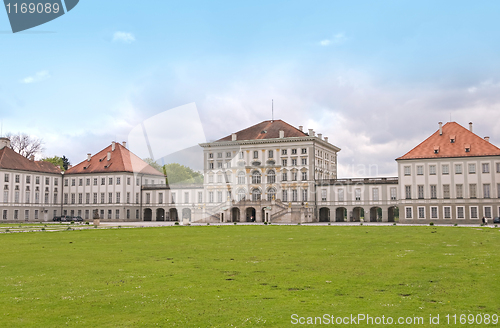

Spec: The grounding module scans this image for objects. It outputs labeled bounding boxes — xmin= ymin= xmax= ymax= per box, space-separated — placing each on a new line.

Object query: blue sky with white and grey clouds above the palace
xmin=0 ymin=0 xmax=500 ymax=178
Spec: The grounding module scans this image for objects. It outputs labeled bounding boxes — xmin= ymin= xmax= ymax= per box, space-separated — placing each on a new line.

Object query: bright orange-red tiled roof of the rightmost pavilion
xmin=397 ymin=122 xmax=500 ymax=159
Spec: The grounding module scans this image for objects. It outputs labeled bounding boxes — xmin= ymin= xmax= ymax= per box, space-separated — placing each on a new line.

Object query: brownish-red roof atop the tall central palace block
xmin=216 ymin=120 xmax=307 ymax=142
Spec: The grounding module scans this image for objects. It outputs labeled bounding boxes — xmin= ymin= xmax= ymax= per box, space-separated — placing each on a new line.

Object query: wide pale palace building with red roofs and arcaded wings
xmin=0 ymin=120 xmax=500 ymax=223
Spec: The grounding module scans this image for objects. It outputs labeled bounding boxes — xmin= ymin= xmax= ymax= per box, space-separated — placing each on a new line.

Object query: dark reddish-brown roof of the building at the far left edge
xmin=0 ymin=147 xmax=61 ymax=174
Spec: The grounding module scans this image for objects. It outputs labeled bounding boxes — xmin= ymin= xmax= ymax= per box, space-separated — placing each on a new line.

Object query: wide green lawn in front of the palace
xmin=0 ymin=225 xmax=500 ymax=327
